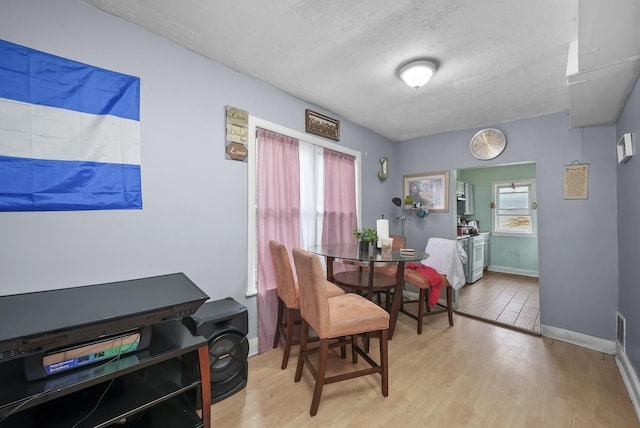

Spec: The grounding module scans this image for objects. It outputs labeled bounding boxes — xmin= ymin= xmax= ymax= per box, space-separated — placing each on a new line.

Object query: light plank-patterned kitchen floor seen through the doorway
xmin=458 ymin=271 xmax=540 ymax=335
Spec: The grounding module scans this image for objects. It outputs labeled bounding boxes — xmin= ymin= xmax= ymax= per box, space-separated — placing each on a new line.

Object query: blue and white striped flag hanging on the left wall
xmin=0 ymin=40 xmax=142 ymax=211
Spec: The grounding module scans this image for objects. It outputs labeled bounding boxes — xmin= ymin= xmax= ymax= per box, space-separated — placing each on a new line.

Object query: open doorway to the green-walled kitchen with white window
xmin=455 ymin=163 xmax=540 ymax=335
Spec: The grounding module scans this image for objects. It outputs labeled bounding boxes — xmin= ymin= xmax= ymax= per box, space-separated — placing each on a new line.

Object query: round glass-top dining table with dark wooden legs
xmin=307 ymin=242 xmax=429 ymax=339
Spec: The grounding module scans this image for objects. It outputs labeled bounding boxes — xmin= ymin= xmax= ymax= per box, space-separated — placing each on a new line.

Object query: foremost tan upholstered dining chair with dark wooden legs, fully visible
xmin=293 ymin=248 xmax=389 ymax=416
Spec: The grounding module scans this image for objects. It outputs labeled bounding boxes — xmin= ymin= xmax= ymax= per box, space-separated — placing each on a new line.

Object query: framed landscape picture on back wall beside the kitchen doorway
xmin=402 ymin=171 xmax=449 ymax=213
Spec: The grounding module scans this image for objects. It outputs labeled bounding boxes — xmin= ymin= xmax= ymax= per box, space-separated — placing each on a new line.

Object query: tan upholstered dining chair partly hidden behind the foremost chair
xmin=269 ymin=240 xmax=344 ymax=370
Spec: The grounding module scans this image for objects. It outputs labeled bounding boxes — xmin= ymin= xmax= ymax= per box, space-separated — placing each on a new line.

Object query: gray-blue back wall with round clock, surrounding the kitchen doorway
xmin=390 ymin=113 xmax=618 ymax=340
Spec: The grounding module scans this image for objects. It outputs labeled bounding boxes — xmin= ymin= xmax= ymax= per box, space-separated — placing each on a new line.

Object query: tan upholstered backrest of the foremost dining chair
xmin=293 ymin=248 xmax=330 ymax=337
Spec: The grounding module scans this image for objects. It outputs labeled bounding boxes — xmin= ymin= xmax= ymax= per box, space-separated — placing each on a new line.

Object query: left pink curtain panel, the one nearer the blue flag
xmin=257 ymin=128 xmax=300 ymax=352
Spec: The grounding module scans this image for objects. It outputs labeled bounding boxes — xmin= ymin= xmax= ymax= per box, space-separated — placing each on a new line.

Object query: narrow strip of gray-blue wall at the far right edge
xmin=616 ymin=75 xmax=640 ymax=373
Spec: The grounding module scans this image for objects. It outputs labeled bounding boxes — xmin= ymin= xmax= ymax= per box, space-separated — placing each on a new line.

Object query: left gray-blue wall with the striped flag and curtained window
xmin=0 ymin=0 xmax=393 ymax=338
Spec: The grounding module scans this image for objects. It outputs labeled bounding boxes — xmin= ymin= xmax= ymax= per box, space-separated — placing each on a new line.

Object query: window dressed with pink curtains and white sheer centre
xmin=248 ymin=121 xmax=359 ymax=352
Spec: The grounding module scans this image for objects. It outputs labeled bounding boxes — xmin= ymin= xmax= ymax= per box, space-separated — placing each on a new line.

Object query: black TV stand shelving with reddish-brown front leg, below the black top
xmin=0 ymin=276 xmax=211 ymax=428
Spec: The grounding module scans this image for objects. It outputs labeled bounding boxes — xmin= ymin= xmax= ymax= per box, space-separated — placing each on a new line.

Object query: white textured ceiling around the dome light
xmin=85 ymin=0 xmax=640 ymax=141
